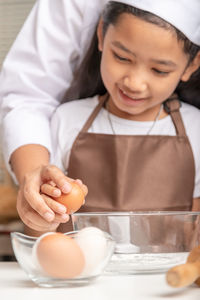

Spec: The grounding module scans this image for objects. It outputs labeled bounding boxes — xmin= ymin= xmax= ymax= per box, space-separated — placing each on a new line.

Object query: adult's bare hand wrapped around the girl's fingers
xmin=17 ymin=165 xmax=86 ymax=234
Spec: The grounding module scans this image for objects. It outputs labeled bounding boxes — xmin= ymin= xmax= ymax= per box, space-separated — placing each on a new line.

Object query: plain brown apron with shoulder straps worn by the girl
xmin=57 ymin=97 xmax=195 ymax=232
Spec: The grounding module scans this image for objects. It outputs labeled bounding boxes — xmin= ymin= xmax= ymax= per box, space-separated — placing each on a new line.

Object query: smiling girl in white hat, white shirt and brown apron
xmin=18 ymin=0 xmax=200 ymax=234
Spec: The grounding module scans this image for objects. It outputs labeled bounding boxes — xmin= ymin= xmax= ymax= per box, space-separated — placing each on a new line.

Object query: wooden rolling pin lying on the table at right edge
xmin=166 ymin=246 xmax=200 ymax=287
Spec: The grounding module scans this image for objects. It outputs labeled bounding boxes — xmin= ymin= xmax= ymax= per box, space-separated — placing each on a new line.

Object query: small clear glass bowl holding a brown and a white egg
xmin=11 ymin=231 xmax=115 ymax=287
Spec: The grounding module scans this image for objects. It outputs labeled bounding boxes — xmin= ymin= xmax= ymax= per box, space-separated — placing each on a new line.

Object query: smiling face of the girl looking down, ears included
xmin=98 ymin=13 xmax=198 ymax=121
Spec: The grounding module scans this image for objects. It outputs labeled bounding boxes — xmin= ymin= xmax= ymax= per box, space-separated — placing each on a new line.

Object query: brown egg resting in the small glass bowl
xmin=36 ymin=233 xmax=85 ymax=279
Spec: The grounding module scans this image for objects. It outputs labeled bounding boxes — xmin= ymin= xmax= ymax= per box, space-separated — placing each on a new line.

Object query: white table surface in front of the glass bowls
xmin=0 ymin=262 xmax=200 ymax=300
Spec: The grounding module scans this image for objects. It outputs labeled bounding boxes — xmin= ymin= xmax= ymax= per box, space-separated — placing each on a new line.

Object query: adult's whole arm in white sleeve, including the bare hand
xmin=0 ymin=0 xmax=108 ymax=234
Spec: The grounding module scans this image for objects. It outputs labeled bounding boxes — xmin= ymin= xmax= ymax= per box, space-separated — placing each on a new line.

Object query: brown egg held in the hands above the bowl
xmin=54 ymin=182 xmax=85 ymax=214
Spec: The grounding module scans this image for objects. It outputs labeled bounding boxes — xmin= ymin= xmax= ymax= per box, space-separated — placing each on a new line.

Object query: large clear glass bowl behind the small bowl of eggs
xmin=72 ymin=211 xmax=200 ymax=275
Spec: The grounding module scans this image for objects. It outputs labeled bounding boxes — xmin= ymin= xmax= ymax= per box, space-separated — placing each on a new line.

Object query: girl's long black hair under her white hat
xmin=64 ymin=1 xmax=200 ymax=108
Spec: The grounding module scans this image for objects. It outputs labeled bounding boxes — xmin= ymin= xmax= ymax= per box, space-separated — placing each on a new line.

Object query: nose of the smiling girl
xmin=124 ymin=74 xmax=147 ymax=93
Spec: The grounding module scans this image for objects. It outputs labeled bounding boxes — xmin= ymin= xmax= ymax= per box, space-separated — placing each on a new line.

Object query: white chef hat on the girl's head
xmin=111 ymin=0 xmax=200 ymax=46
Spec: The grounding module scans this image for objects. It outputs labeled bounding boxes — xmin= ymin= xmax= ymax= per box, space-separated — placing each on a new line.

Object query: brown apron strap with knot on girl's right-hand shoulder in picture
xmin=164 ymin=94 xmax=187 ymax=136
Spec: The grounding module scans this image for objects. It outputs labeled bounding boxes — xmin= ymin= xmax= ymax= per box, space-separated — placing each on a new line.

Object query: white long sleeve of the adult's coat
xmin=0 ymin=0 xmax=108 ymax=176
